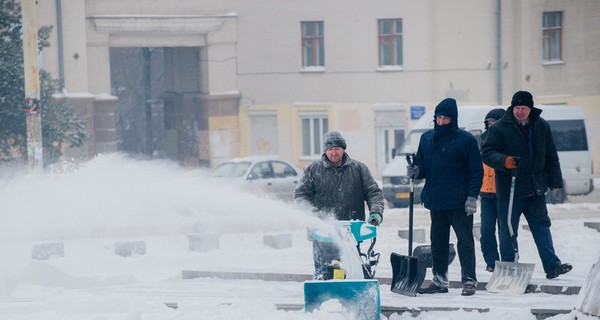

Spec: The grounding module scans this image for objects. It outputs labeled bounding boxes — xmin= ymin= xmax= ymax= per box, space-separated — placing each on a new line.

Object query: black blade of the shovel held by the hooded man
xmin=390 ymin=252 xmax=427 ymax=297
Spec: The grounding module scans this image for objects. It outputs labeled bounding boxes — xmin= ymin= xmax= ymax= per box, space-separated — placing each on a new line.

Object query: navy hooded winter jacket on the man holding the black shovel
xmin=415 ymin=99 xmax=483 ymax=211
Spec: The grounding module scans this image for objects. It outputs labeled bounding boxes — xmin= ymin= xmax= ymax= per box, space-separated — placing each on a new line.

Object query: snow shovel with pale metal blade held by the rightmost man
xmin=485 ymin=157 xmax=535 ymax=294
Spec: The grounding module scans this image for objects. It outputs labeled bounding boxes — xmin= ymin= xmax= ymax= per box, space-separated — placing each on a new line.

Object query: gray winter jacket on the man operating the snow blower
xmin=294 ymin=153 xmax=384 ymax=221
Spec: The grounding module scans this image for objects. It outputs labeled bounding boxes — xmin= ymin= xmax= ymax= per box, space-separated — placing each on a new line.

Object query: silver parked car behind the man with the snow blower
xmin=210 ymin=156 xmax=302 ymax=201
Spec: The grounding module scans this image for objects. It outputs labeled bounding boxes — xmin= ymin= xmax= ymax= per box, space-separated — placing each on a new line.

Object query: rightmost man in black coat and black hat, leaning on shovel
xmin=482 ymin=91 xmax=573 ymax=279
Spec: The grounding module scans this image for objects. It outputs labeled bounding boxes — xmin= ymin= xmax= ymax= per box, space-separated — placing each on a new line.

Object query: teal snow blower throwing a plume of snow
xmin=304 ymin=220 xmax=381 ymax=320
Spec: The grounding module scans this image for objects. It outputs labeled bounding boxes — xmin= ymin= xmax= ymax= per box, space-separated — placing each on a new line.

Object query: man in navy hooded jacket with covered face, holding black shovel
xmin=407 ymin=98 xmax=483 ymax=296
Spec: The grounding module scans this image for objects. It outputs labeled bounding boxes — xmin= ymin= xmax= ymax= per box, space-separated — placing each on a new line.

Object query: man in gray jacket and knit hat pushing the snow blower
xmin=294 ymin=131 xmax=384 ymax=280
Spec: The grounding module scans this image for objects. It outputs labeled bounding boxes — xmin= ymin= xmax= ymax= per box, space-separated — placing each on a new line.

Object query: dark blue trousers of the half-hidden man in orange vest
xmin=479 ymin=197 xmax=500 ymax=268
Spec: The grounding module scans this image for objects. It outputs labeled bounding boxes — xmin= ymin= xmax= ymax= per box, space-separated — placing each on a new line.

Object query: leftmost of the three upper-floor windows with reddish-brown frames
xmin=302 ymin=21 xmax=325 ymax=67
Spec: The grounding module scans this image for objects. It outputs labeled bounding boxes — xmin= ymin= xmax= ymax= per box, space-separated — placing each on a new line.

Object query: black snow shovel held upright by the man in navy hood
xmin=390 ymin=154 xmax=427 ymax=297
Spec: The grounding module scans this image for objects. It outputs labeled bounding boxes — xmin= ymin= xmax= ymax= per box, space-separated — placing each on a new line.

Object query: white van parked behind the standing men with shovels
xmin=382 ymin=105 xmax=593 ymax=208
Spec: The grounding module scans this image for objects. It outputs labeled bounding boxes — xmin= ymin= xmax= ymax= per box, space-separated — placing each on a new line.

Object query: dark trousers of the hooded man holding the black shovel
xmin=430 ymin=208 xmax=477 ymax=287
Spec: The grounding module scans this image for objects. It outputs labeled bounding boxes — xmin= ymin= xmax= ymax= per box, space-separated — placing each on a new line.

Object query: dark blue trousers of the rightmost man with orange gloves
xmin=498 ymin=196 xmax=561 ymax=273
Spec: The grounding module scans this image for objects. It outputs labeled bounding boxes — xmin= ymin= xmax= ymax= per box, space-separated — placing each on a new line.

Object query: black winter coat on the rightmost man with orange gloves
xmin=482 ymin=107 xmax=563 ymax=198
